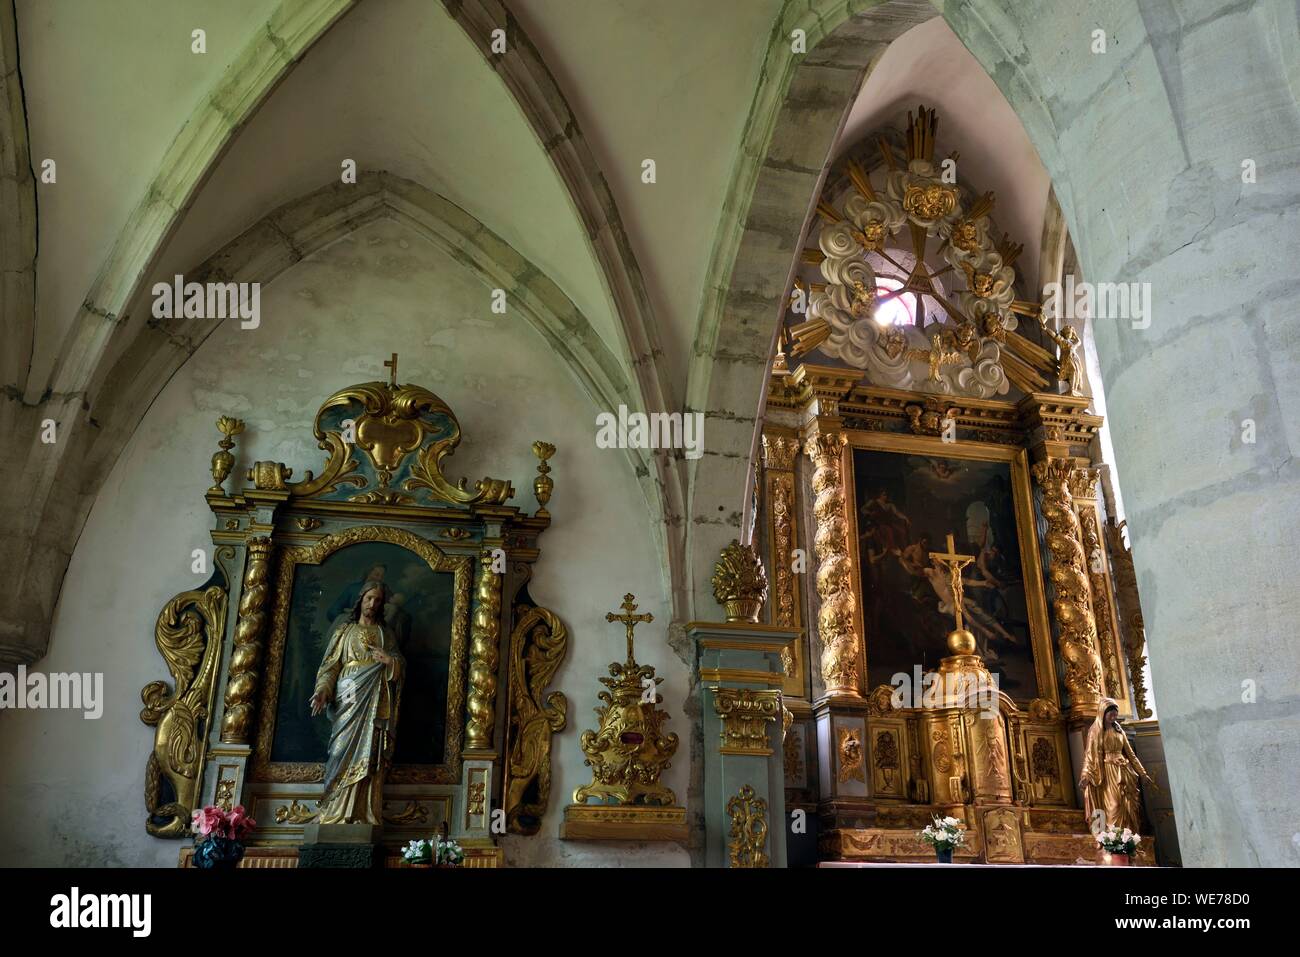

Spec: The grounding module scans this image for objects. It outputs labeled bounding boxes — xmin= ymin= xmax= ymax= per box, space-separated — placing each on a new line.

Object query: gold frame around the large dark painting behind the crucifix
xmin=841 ymin=429 xmax=1061 ymax=710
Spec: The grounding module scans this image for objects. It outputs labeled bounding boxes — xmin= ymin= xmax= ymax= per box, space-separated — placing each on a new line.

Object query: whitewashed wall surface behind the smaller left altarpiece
xmin=0 ymin=221 xmax=689 ymax=866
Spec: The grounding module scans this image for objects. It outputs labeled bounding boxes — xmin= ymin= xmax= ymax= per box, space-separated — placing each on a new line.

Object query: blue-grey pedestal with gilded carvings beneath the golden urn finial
xmin=686 ymin=622 xmax=798 ymax=867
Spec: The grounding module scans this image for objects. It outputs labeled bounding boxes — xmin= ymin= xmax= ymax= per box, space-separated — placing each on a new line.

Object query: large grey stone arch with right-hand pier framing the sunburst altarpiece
xmin=689 ymin=0 xmax=1300 ymax=866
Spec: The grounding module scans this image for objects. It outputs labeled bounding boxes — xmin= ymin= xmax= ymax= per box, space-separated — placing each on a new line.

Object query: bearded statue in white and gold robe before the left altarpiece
xmin=311 ymin=581 xmax=406 ymax=824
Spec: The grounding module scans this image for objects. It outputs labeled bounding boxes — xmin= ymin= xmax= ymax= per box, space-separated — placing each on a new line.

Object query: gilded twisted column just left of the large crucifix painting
xmin=805 ymin=432 xmax=861 ymax=697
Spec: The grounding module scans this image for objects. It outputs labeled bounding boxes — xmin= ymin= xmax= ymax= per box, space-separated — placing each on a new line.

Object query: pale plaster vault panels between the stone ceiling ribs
xmin=17 ymin=0 xmax=780 ymax=402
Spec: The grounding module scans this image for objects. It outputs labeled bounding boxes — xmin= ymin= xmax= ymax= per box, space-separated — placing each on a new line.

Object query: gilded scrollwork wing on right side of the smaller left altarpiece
xmin=506 ymin=607 xmax=568 ymax=833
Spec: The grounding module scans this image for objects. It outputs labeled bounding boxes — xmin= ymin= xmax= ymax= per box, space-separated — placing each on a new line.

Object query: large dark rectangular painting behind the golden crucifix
xmin=853 ymin=449 xmax=1037 ymax=701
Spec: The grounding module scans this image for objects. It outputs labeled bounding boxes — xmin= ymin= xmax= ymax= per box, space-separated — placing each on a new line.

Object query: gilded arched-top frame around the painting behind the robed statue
xmin=251 ymin=525 xmax=473 ymax=784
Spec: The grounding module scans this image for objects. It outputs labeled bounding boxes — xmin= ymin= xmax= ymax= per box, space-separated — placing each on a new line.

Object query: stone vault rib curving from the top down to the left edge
xmin=0 ymin=0 xmax=355 ymax=663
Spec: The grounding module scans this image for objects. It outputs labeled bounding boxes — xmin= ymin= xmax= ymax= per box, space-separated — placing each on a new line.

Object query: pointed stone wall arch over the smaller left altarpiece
xmin=7 ymin=172 xmax=680 ymax=662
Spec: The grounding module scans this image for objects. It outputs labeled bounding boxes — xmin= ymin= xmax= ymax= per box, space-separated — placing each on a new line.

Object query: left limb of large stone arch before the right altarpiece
xmin=686 ymin=0 xmax=939 ymax=616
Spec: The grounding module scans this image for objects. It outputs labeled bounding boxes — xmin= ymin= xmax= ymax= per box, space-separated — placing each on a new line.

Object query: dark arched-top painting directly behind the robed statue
xmin=270 ymin=541 xmax=455 ymax=765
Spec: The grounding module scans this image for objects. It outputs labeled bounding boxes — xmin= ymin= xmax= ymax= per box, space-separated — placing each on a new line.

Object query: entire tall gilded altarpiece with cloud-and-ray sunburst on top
xmin=757 ymin=107 xmax=1149 ymax=863
